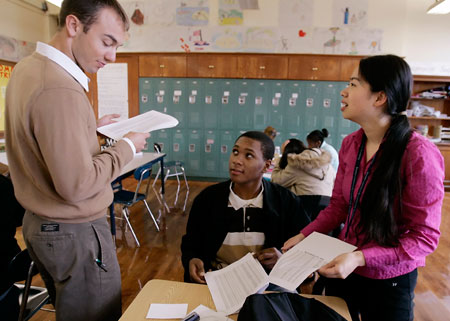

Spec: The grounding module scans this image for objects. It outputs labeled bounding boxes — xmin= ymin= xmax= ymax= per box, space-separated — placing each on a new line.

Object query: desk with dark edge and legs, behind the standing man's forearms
xmin=109 ymin=152 xmax=166 ymax=239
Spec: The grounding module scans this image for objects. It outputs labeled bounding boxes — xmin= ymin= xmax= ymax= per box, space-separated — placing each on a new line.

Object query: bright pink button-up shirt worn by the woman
xmin=302 ymin=129 xmax=444 ymax=279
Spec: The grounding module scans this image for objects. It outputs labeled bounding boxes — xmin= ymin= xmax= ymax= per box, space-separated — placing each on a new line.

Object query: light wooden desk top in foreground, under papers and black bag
xmin=120 ymin=280 xmax=351 ymax=321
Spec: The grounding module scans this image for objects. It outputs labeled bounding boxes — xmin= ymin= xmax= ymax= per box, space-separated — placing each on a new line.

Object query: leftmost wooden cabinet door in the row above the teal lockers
xmin=139 ymin=53 xmax=187 ymax=78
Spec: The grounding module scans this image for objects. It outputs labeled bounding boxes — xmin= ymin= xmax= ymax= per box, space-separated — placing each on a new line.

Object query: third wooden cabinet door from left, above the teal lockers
xmin=237 ymin=55 xmax=289 ymax=79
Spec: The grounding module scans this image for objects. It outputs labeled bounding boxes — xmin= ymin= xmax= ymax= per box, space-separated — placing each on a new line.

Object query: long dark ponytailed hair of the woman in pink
xmin=358 ymin=55 xmax=412 ymax=246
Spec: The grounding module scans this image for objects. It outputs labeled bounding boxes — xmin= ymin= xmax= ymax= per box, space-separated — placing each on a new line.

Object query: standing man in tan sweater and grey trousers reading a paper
xmin=6 ymin=0 xmax=149 ymax=321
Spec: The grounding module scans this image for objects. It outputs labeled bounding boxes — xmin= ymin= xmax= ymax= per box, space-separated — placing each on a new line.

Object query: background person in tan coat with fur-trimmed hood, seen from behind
xmin=272 ymin=138 xmax=336 ymax=220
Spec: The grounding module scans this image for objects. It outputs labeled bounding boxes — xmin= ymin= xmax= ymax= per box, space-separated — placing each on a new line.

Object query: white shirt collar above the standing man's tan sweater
xmin=36 ymin=42 xmax=89 ymax=91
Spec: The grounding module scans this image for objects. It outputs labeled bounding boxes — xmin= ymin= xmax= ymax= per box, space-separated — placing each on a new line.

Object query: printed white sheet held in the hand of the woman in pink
xmin=269 ymin=232 xmax=356 ymax=291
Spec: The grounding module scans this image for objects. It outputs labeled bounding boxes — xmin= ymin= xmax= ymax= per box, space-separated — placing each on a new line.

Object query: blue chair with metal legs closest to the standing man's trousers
xmin=112 ymin=164 xmax=159 ymax=247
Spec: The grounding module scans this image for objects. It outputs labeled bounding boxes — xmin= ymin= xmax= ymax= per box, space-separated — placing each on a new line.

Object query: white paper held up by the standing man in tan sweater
xmin=97 ymin=110 xmax=178 ymax=140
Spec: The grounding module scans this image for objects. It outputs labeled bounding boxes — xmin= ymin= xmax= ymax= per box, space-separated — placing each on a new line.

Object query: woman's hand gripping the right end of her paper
xmin=319 ymin=251 xmax=366 ymax=279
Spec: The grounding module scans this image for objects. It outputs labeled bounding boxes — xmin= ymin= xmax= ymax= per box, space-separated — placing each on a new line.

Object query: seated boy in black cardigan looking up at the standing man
xmin=181 ymin=131 xmax=310 ymax=283
